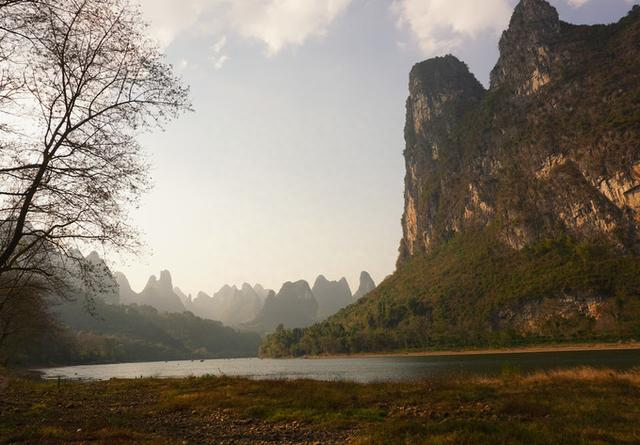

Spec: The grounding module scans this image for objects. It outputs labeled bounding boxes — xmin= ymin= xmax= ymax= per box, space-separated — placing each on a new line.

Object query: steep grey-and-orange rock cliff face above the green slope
xmin=398 ymin=0 xmax=640 ymax=265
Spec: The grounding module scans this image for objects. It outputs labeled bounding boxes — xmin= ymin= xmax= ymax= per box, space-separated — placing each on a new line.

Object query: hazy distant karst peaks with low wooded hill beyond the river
xmin=43 ymin=252 xmax=375 ymax=364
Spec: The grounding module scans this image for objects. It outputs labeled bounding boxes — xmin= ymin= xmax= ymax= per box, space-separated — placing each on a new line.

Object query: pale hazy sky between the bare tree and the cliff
xmin=117 ymin=0 xmax=637 ymax=294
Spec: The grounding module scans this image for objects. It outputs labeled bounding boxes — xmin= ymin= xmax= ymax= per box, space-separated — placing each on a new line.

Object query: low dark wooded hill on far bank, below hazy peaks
xmin=7 ymin=300 xmax=260 ymax=365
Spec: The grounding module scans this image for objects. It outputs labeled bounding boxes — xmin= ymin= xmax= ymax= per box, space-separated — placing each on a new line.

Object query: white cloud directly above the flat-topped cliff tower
xmin=392 ymin=0 xmax=513 ymax=55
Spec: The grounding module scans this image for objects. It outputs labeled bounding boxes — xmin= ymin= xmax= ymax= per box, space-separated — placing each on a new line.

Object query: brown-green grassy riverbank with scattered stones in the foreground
xmin=0 ymin=368 xmax=640 ymax=445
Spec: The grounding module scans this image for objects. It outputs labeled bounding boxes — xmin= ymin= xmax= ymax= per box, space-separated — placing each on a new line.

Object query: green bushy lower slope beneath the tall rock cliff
xmin=261 ymin=234 xmax=640 ymax=357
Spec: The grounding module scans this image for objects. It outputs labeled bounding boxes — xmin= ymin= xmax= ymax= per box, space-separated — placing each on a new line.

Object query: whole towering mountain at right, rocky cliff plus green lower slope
xmin=262 ymin=0 xmax=640 ymax=356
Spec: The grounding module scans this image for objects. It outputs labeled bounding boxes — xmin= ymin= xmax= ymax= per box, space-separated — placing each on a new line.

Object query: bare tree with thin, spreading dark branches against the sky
xmin=0 ymin=0 xmax=190 ymax=278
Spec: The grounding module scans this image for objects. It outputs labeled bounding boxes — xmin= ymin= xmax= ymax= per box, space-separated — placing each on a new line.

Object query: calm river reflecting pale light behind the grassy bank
xmin=42 ymin=350 xmax=640 ymax=382
